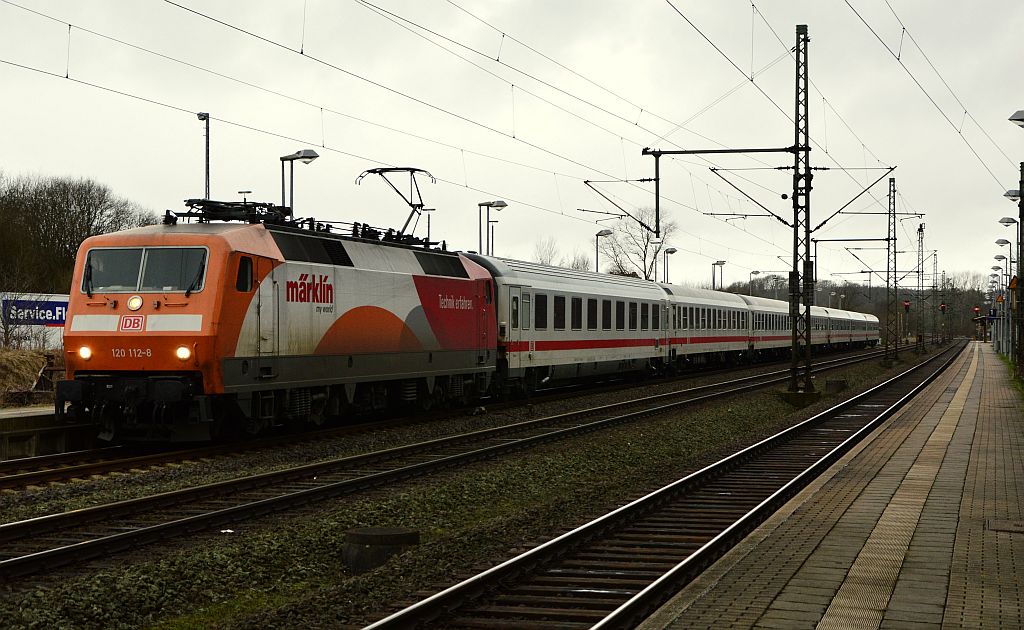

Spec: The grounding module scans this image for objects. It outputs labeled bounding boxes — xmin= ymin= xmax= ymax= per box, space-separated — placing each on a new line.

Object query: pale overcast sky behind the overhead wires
xmin=0 ymin=0 xmax=1024 ymax=285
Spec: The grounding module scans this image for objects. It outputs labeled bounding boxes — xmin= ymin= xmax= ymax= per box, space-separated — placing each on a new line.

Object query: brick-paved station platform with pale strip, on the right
xmin=640 ymin=342 xmax=1024 ymax=630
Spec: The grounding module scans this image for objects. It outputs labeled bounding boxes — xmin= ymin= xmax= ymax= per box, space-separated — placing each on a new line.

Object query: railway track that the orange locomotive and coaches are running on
xmin=0 ymin=351 xmax=880 ymax=490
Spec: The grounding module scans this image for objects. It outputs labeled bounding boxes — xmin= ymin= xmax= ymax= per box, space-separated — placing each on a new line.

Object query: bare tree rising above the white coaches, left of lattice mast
xmin=601 ymin=208 xmax=677 ymax=280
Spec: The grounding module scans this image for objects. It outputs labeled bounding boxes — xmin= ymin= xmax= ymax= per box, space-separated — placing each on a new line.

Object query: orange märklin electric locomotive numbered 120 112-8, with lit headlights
xmin=56 ymin=200 xmax=497 ymax=442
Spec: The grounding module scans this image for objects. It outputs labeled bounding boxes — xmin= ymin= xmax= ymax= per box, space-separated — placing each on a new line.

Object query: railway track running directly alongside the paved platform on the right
xmin=369 ymin=345 xmax=963 ymax=630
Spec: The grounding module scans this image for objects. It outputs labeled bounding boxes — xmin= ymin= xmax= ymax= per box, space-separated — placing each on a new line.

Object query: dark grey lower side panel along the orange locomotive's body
xmin=221 ymin=350 xmax=495 ymax=393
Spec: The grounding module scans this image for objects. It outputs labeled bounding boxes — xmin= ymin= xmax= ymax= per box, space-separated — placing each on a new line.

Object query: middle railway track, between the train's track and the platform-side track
xmin=0 ymin=354 xmax=888 ymax=581
